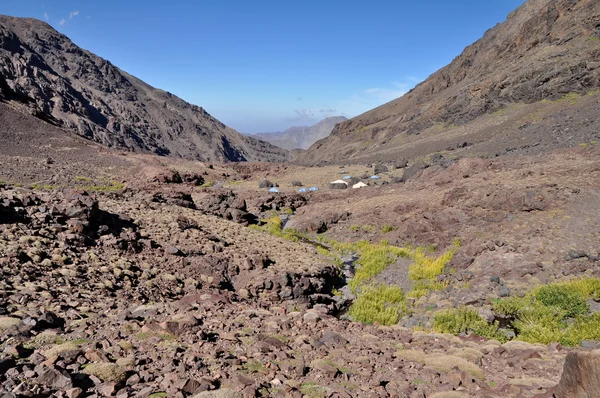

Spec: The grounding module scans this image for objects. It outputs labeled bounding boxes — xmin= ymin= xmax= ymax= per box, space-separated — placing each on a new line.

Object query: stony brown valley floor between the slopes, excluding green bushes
xmin=0 ymin=117 xmax=600 ymax=398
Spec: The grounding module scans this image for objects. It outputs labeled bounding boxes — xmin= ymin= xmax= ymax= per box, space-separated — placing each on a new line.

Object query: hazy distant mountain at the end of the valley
xmin=253 ymin=116 xmax=348 ymax=150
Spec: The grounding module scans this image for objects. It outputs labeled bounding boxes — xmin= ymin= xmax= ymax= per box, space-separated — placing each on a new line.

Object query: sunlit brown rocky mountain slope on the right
xmin=299 ymin=0 xmax=600 ymax=163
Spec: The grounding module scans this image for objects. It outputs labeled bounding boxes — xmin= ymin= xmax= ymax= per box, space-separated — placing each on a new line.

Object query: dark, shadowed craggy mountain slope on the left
xmin=0 ymin=15 xmax=286 ymax=161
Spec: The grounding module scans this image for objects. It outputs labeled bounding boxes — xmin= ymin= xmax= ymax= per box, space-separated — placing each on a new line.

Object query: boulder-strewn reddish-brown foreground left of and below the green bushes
xmin=0 ymin=175 xmax=566 ymax=397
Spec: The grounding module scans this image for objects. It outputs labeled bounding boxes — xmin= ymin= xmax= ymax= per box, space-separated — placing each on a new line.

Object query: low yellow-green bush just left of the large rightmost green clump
xmin=433 ymin=308 xmax=507 ymax=342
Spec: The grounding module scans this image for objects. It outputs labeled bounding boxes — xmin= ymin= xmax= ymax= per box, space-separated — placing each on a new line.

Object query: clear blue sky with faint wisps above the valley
xmin=0 ymin=0 xmax=524 ymax=133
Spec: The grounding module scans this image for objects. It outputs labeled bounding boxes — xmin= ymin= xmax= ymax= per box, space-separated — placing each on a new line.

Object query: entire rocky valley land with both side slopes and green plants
xmin=0 ymin=0 xmax=600 ymax=398
